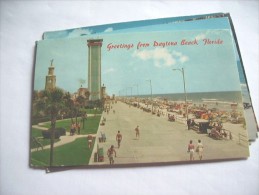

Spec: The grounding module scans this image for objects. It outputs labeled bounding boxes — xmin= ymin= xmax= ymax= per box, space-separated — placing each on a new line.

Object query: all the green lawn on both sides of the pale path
xmin=31 ymin=115 xmax=101 ymax=166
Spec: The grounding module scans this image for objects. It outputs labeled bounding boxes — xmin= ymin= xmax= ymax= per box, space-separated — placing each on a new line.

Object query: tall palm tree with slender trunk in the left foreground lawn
xmin=36 ymin=88 xmax=65 ymax=166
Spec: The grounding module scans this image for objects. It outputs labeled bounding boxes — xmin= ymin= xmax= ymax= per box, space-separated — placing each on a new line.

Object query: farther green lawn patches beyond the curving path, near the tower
xmin=40 ymin=115 xmax=101 ymax=135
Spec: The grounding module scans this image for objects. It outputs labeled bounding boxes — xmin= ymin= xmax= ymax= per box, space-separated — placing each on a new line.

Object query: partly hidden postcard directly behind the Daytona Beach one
xmin=44 ymin=13 xmax=258 ymax=141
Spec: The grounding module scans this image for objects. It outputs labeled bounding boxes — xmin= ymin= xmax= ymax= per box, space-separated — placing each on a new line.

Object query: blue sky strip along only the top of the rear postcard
xmin=44 ymin=13 xmax=226 ymax=39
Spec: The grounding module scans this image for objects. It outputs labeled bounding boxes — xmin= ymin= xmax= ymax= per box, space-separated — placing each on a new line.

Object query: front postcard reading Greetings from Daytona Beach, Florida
xmin=30 ymin=30 xmax=249 ymax=168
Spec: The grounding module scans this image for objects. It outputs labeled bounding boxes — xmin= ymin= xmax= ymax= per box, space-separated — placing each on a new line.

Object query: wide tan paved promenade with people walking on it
xmin=89 ymin=102 xmax=248 ymax=165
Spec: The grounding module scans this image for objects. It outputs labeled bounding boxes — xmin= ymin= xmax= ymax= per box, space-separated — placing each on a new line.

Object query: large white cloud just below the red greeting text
xmin=132 ymin=48 xmax=189 ymax=68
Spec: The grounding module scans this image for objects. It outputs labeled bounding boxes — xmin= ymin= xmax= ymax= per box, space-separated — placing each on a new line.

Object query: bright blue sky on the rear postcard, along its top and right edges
xmin=41 ymin=14 xmax=247 ymax=88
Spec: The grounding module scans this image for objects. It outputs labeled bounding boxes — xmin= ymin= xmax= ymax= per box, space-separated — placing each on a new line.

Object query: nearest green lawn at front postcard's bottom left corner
xmin=31 ymin=138 xmax=95 ymax=166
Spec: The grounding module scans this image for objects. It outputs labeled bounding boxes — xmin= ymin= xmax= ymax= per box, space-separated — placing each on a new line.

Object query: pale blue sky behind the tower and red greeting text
xmin=34 ymin=30 xmax=243 ymax=95
